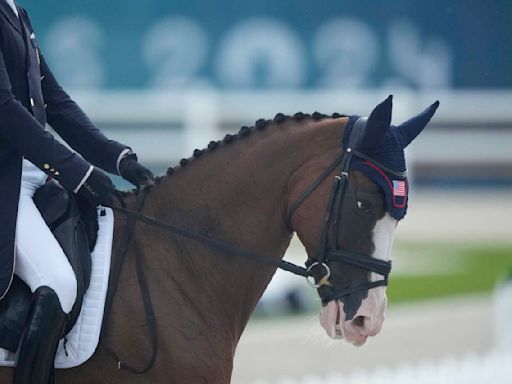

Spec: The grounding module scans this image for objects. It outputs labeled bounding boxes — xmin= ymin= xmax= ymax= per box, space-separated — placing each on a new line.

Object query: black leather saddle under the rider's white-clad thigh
xmin=0 ymin=181 xmax=98 ymax=352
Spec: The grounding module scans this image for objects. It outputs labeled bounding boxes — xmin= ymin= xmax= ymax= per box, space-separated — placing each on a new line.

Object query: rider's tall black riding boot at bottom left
xmin=13 ymin=287 xmax=67 ymax=384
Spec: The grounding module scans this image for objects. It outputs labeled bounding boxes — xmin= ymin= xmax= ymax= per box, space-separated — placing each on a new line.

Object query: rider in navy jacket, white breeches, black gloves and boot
xmin=0 ymin=0 xmax=153 ymax=384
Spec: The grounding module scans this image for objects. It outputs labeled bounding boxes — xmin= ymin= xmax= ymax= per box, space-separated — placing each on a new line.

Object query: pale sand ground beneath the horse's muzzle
xmin=232 ymin=296 xmax=493 ymax=384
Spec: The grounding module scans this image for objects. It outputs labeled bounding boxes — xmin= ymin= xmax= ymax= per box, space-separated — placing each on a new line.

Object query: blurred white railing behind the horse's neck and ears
xmin=73 ymin=90 xmax=512 ymax=181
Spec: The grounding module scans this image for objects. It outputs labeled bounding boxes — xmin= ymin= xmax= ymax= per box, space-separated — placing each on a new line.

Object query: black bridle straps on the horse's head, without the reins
xmin=287 ymin=117 xmax=395 ymax=305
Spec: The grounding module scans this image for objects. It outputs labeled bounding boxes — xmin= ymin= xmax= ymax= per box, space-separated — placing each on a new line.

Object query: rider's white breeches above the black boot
xmin=14 ymin=159 xmax=77 ymax=313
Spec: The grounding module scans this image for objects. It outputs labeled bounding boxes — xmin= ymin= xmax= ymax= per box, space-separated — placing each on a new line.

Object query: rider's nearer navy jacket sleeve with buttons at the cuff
xmin=0 ymin=49 xmax=91 ymax=190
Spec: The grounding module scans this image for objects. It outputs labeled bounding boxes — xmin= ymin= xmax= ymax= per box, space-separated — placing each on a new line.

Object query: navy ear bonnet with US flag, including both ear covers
xmin=343 ymin=96 xmax=439 ymax=220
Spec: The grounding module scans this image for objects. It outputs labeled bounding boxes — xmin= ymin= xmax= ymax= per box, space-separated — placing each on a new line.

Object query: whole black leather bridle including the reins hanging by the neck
xmin=102 ymin=117 xmax=395 ymax=374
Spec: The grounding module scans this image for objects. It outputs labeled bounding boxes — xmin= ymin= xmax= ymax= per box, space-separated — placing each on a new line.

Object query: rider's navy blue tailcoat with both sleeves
xmin=0 ymin=0 xmax=127 ymax=298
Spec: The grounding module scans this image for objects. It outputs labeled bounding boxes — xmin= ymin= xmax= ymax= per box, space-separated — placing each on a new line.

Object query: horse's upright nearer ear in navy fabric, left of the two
xmin=360 ymin=95 xmax=393 ymax=152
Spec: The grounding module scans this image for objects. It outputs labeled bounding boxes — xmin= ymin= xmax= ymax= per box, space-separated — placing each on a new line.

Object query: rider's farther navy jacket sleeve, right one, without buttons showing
xmin=40 ymin=55 xmax=130 ymax=174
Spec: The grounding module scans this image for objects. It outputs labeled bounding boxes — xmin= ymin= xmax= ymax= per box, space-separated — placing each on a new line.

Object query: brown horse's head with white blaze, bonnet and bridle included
xmin=289 ymin=96 xmax=439 ymax=345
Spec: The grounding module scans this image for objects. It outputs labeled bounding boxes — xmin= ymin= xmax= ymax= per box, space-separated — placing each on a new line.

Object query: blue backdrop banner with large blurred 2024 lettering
xmin=19 ymin=0 xmax=512 ymax=90
